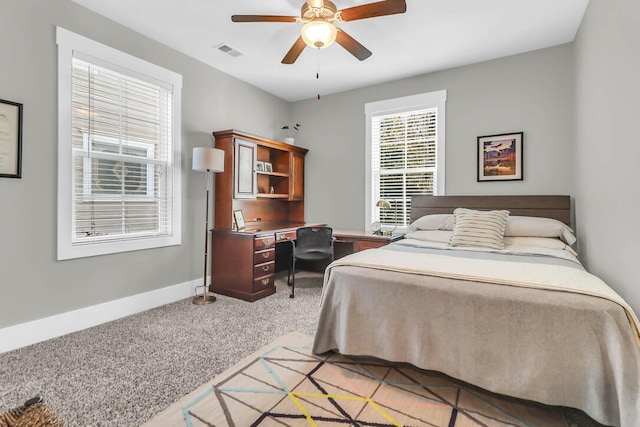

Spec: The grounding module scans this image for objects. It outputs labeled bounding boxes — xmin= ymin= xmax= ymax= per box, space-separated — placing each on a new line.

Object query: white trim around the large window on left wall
xmin=56 ymin=27 xmax=182 ymax=260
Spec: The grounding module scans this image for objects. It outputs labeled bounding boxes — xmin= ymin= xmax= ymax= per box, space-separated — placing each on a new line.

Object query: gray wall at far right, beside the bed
xmin=574 ymin=0 xmax=640 ymax=312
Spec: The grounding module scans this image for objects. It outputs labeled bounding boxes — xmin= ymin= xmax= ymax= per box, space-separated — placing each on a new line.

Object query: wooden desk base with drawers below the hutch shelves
xmin=209 ymin=222 xmax=324 ymax=302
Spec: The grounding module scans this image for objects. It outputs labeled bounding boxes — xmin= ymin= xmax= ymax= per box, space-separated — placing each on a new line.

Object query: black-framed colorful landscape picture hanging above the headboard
xmin=477 ymin=132 xmax=524 ymax=182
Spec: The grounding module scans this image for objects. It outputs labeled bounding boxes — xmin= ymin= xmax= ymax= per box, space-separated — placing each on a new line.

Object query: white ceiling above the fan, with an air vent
xmin=72 ymin=0 xmax=589 ymax=101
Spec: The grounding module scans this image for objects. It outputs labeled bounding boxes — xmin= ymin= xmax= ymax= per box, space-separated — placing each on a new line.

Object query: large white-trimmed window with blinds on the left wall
xmin=57 ymin=28 xmax=182 ymax=259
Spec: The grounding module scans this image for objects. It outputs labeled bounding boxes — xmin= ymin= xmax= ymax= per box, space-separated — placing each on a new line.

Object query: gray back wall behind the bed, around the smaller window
xmin=292 ymin=44 xmax=574 ymax=229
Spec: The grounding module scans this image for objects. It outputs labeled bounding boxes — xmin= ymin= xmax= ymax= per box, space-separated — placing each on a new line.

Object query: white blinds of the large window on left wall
xmin=72 ymin=58 xmax=172 ymax=244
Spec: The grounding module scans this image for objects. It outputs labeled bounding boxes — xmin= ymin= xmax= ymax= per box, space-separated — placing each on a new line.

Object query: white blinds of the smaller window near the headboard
xmin=371 ymin=108 xmax=438 ymax=227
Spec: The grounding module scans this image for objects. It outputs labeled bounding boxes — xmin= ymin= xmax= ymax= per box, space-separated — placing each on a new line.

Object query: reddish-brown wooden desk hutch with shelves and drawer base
xmin=210 ymin=130 xmax=308 ymax=301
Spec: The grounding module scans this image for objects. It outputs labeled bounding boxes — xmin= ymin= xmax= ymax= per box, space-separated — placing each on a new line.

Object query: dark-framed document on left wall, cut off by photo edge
xmin=0 ymin=99 xmax=22 ymax=178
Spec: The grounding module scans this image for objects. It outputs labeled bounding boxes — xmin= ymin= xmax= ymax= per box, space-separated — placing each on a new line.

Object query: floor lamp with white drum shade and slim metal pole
xmin=191 ymin=147 xmax=224 ymax=305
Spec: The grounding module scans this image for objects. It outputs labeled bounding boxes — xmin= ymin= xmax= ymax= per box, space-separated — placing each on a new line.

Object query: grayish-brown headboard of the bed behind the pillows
xmin=411 ymin=196 xmax=571 ymax=226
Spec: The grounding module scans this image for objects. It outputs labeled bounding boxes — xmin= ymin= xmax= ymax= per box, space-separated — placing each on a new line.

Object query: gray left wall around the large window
xmin=0 ymin=0 xmax=288 ymax=328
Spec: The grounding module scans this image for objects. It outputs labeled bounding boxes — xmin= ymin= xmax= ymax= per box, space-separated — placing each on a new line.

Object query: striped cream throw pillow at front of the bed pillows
xmin=449 ymin=208 xmax=509 ymax=249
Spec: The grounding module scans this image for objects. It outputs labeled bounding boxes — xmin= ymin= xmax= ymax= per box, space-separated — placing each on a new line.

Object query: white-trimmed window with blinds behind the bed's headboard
xmin=365 ymin=91 xmax=446 ymax=229
